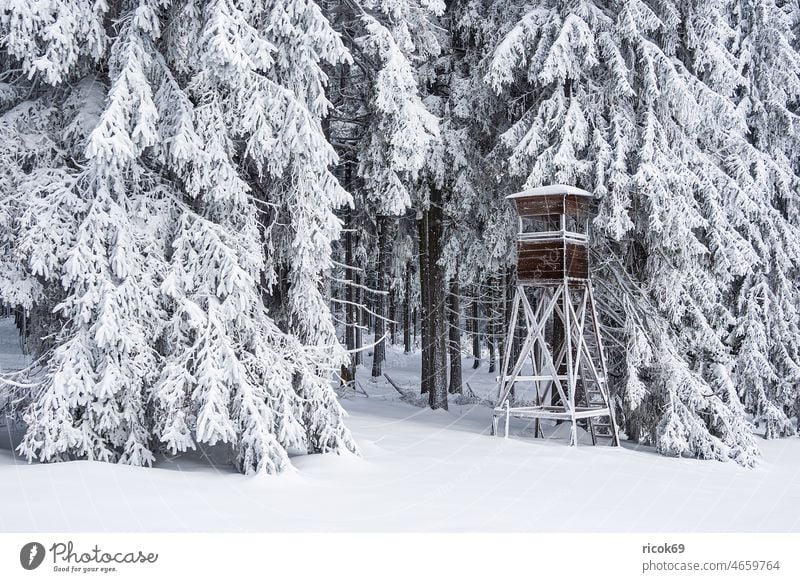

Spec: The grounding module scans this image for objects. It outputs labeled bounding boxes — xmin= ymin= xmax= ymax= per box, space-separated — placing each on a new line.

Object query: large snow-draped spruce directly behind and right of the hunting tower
xmin=465 ymin=0 xmax=796 ymax=464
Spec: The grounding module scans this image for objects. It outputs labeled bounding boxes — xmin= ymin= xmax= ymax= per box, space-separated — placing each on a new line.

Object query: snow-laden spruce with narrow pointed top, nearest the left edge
xmin=4 ymin=16 xmax=170 ymax=465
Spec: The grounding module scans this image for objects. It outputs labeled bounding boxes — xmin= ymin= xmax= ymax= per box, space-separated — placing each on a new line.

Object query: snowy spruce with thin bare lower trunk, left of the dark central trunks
xmin=331 ymin=0 xmax=444 ymax=388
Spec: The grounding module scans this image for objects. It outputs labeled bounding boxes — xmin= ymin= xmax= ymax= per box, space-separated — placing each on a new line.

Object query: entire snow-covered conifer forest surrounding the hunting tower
xmin=0 ymin=0 xmax=800 ymax=506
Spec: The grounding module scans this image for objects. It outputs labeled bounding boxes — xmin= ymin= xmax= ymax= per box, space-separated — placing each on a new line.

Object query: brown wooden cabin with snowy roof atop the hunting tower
xmin=507 ymin=184 xmax=594 ymax=283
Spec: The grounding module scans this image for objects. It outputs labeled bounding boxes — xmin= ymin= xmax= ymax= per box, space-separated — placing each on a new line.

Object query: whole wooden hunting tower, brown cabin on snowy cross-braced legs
xmin=492 ymin=185 xmax=619 ymax=446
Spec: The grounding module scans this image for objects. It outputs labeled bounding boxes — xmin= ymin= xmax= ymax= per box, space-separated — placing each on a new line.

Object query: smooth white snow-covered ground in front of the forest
xmin=0 ymin=322 xmax=800 ymax=532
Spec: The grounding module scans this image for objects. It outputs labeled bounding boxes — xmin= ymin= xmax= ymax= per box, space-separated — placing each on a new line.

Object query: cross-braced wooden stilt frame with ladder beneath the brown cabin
xmin=492 ymin=278 xmax=619 ymax=446
